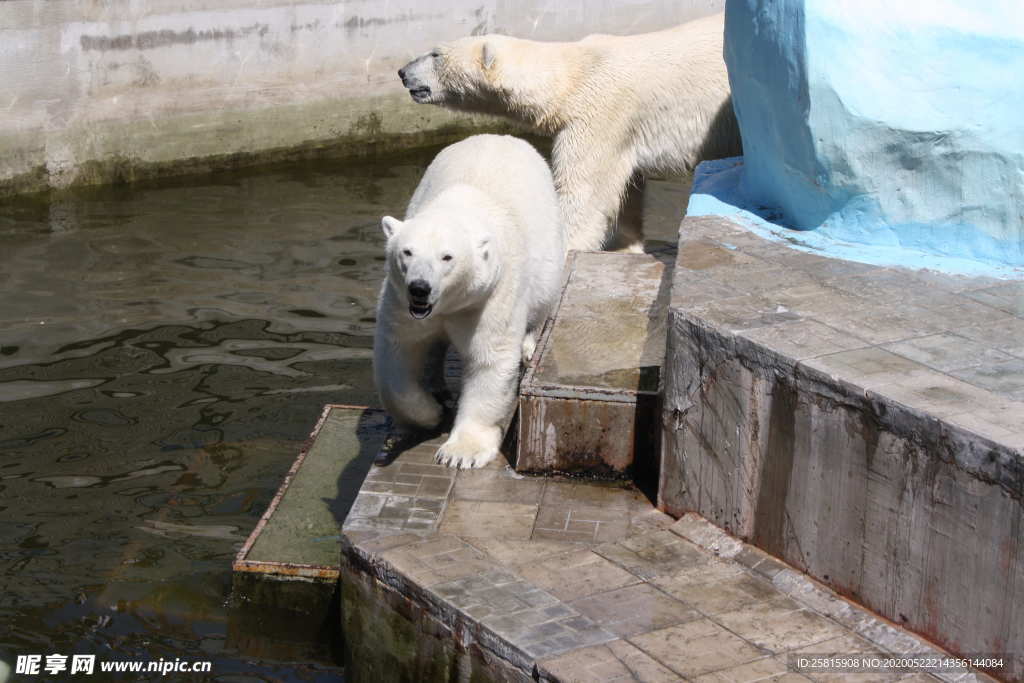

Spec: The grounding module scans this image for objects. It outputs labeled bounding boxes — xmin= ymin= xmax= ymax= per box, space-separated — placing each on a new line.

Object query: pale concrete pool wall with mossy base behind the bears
xmin=0 ymin=0 xmax=723 ymax=196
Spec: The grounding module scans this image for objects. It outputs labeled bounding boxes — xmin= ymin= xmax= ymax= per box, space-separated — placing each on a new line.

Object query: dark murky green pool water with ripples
xmin=0 ymin=147 xmax=685 ymax=681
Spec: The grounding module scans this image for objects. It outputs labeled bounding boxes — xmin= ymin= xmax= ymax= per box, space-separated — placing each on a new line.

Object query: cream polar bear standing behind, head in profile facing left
xmin=398 ymin=14 xmax=741 ymax=252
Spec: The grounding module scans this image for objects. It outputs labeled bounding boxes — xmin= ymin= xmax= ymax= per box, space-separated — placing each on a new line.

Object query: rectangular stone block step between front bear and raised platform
xmin=515 ymin=252 xmax=669 ymax=477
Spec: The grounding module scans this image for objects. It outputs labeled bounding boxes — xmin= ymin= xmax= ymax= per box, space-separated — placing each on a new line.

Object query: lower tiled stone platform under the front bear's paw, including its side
xmin=342 ymin=432 xmax=995 ymax=682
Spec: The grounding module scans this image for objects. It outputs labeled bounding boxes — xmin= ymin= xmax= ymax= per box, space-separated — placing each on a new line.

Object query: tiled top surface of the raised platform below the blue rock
xmin=671 ymin=216 xmax=1024 ymax=449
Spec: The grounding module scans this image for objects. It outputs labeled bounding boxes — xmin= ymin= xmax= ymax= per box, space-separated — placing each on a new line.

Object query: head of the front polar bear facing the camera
xmin=381 ymin=211 xmax=500 ymax=319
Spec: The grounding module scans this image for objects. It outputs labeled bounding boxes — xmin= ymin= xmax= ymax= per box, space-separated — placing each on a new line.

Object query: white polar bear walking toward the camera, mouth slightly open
xmin=374 ymin=135 xmax=565 ymax=467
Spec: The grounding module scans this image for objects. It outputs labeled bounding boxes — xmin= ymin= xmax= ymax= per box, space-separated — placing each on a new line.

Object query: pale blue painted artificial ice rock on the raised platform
xmin=725 ymin=0 xmax=1024 ymax=266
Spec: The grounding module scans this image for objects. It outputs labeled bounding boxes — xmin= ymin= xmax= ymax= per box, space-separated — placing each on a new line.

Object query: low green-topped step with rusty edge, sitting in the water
xmin=228 ymin=405 xmax=386 ymax=661
